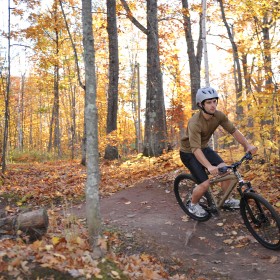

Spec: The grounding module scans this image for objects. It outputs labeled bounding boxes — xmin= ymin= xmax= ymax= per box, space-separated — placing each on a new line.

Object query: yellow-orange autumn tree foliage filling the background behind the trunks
xmin=0 ymin=0 xmax=280 ymax=163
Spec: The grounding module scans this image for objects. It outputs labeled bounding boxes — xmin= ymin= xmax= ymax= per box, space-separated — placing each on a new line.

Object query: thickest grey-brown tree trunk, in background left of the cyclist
xmin=143 ymin=0 xmax=167 ymax=156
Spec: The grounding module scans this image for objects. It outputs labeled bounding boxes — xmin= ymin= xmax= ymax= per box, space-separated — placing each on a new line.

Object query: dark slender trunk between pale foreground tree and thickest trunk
xmin=104 ymin=0 xmax=119 ymax=159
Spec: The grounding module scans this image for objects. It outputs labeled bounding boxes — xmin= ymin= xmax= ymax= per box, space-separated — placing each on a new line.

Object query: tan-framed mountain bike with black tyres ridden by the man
xmin=174 ymin=153 xmax=280 ymax=250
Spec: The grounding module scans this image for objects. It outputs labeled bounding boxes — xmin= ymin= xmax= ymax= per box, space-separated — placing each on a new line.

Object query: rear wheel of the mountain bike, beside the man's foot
xmin=174 ymin=174 xmax=211 ymax=222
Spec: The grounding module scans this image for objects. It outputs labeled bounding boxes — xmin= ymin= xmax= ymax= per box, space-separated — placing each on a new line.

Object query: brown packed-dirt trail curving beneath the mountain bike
xmin=69 ymin=174 xmax=280 ymax=280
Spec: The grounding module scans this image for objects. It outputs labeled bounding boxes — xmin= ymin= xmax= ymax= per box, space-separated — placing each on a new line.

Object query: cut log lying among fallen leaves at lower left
xmin=0 ymin=208 xmax=49 ymax=241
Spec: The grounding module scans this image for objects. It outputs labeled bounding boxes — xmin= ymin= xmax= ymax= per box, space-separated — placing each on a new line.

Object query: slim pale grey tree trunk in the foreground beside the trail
xmin=82 ymin=0 xmax=102 ymax=257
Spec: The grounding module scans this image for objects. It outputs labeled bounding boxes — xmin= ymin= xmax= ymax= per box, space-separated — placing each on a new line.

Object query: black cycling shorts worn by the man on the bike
xmin=180 ymin=147 xmax=224 ymax=184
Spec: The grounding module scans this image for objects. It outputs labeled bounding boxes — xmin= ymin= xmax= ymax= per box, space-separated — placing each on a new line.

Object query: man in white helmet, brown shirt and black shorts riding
xmin=180 ymin=87 xmax=257 ymax=217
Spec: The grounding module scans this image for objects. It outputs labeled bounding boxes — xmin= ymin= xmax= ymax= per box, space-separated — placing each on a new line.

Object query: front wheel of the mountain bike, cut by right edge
xmin=240 ymin=192 xmax=280 ymax=250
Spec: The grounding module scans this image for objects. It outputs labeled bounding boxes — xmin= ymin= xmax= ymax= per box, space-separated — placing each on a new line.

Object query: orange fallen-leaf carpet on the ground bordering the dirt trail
xmin=0 ymin=151 xmax=280 ymax=279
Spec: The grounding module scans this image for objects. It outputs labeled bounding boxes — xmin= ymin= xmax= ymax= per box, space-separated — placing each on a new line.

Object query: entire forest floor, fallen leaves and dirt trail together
xmin=0 ymin=149 xmax=280 ymax=280
